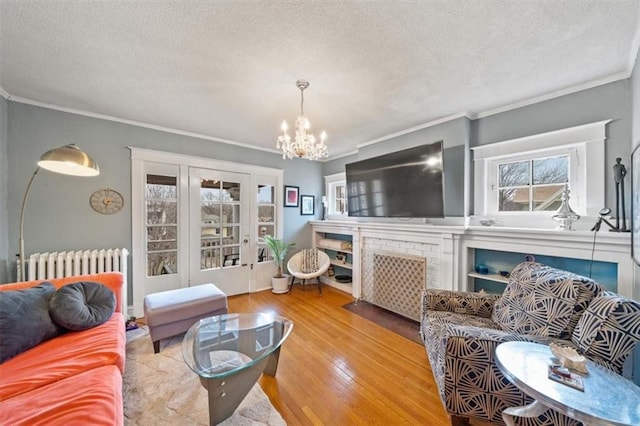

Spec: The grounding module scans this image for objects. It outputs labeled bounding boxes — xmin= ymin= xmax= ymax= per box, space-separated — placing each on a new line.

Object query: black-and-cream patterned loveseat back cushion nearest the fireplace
xmin=492 ymin=262 xmax=578 ymax=338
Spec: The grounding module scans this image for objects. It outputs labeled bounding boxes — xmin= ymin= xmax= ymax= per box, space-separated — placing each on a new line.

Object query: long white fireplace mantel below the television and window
xmin=311 ymin=220 xmax=640 ymax=297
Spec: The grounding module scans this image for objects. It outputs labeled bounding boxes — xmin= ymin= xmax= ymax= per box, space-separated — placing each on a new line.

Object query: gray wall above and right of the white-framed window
xmin=471 ymin=80 xmax=631 ymax=217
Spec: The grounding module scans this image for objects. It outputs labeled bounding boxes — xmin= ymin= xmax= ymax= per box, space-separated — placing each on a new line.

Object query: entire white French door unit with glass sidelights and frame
xmin=130 ymin=148 xmax=283 ymax=316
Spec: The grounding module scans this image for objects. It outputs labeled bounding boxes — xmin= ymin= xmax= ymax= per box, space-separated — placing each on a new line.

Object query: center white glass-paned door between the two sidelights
xmin=189 ymin=168 xmax=255 ymax=296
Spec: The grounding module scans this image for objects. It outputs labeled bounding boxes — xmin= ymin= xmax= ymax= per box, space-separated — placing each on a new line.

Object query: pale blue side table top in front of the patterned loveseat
xmin=496 ymin=342 xmax=640 ymax=425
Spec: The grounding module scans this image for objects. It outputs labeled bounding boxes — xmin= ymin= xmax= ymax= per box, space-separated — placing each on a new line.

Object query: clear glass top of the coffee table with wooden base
xmin=182 ymin=313 xmax=293 ymax=378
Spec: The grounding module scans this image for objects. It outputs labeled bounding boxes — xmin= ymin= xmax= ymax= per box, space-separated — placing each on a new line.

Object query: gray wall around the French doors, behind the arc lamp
xmin=0 ymin=101 xmax=322 ymax=284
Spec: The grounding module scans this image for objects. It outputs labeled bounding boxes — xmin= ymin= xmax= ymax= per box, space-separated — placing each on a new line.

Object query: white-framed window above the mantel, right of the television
xmin=472 ymin=120 xmax=610 ymax=218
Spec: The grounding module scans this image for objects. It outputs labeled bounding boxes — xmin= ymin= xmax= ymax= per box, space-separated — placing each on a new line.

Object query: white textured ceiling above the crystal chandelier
xmin=0 ymin=0 xmax=640 ymax=157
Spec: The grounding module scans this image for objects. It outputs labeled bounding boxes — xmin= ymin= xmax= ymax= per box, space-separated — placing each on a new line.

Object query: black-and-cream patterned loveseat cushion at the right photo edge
xmin=571 ymin=291 xmax=640 ymax=373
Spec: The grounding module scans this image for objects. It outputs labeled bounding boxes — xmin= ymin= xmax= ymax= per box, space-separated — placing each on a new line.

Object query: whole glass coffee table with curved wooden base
xmin=182 ymin=314 xmax=293 ymax=425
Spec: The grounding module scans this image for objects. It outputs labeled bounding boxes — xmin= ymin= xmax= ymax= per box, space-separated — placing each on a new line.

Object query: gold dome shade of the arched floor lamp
xmin=38 ymin=144 xmax=100 ymax=176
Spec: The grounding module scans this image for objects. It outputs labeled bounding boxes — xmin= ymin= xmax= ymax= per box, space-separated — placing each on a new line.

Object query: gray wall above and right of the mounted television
xmin=323 ymin=118 xmax=469 ymax=217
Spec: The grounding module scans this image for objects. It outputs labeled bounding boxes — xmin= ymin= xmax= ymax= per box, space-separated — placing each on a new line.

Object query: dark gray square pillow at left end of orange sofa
xmin=0 ymin=282 xmax=64 ymax=363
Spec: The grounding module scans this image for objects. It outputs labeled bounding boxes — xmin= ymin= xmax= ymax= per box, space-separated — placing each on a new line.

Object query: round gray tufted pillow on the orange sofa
xmin=49 ymin=282 xmax=116 ymax=331
